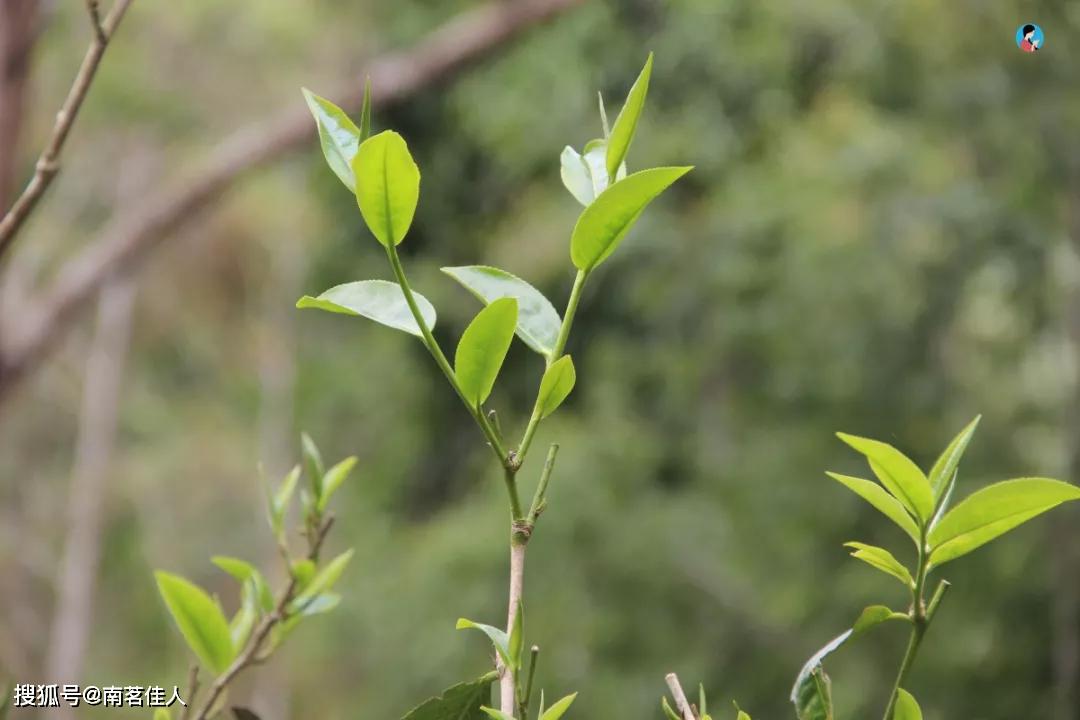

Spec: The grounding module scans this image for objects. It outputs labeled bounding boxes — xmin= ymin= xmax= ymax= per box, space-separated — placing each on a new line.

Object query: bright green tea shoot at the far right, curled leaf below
xmin=662 ymin=418 xmax=1080 ymax=720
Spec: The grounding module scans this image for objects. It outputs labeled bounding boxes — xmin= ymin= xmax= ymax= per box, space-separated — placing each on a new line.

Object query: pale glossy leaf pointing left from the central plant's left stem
xmin=296 ymin=280 xmax=435 ymax=338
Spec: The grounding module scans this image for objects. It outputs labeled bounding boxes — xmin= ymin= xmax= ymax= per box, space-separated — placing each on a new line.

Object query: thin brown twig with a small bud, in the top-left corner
xmin=0 ymin=0 xmax=132 ymax=257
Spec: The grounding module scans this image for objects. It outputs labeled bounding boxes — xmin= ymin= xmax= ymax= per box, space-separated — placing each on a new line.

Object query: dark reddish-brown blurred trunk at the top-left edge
xmin=0 ymin=0 xmax=38 ymax=215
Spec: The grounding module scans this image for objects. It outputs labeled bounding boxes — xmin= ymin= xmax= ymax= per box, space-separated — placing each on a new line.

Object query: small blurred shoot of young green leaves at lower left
xmin=154 ymin=435 xmax=356 ymax=720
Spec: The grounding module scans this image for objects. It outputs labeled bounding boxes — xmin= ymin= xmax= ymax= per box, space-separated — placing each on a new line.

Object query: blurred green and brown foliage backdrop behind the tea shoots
xmin=0 ymin=0 xmax=1080 ymax=720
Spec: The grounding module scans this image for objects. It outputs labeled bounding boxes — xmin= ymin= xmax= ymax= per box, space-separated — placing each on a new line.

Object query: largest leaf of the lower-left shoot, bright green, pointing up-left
xmin=154 ymin=570 xmax=233 ymax=675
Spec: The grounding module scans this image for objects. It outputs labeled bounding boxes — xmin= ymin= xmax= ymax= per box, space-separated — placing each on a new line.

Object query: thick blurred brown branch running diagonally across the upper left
xmin=0 ymin=0 xmax=584 ymax=397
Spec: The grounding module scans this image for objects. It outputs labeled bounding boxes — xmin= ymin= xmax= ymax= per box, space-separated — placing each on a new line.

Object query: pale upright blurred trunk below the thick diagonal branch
xmin=44 ymin=279 xmax=135 ymax=703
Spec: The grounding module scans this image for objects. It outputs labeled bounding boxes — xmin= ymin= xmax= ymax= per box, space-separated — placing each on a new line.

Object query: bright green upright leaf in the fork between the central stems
xmin=454 ymin=298 xmax=517 ymax=407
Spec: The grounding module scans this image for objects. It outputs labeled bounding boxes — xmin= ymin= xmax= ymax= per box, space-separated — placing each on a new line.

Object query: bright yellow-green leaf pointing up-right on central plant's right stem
xmin=570 ymin=167 xmax=692 ymax=270
